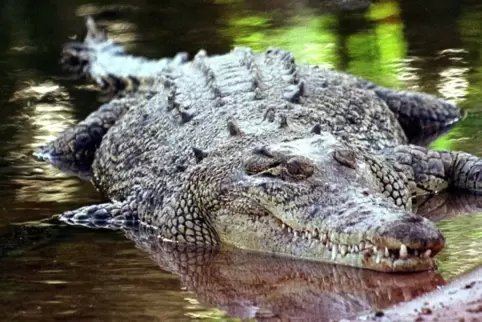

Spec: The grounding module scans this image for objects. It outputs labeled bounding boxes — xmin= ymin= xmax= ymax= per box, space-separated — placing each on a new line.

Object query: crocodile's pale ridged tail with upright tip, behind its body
xmin=61 ymin=17 xmax=188 ymax=95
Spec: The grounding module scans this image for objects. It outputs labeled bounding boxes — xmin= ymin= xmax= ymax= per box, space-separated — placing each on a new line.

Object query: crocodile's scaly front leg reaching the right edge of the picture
xmin=387 ymin=145 xmax=482 ymax=195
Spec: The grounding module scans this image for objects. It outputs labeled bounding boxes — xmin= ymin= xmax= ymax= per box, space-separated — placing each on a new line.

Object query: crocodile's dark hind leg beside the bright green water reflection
xmin=369 ymin=84 xmax=463 ymax=145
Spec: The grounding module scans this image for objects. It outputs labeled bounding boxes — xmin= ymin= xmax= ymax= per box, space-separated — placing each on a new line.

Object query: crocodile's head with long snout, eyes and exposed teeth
xmin=180 ymin=135 xmax=444 ymax=272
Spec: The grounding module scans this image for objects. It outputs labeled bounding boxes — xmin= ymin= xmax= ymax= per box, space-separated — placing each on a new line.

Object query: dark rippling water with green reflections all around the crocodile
xmin=0 ymin=0 xmax=482 ymax=321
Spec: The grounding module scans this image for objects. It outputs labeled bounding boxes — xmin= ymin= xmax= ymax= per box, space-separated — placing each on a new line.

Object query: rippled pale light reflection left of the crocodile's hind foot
xmin=6 ymin=82 xmax=86 ymax=205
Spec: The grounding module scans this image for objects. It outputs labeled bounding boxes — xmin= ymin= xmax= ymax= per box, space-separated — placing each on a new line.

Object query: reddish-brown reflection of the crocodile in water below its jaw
xmin=126 ymin=231 xmax=444 ymax=321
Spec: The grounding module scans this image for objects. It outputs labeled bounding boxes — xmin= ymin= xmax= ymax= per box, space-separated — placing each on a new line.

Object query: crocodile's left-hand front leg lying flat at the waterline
xmin=60 ymin=201 xmax=138 ymax=229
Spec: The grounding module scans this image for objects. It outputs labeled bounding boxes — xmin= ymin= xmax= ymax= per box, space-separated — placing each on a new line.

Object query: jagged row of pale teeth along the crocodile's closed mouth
xmin=276 ymin=218 xmax=435 ymax=264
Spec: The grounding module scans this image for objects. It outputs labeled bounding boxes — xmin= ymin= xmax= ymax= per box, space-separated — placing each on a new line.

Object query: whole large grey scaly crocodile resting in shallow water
xmin=37 ymin=19 xmax=482 ymax=272
